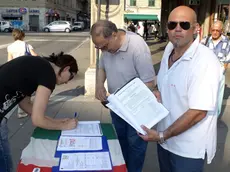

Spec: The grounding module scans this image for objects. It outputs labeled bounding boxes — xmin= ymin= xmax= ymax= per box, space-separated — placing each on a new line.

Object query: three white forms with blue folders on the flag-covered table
xmin=53 ymin=121 xmax=112 ymax=172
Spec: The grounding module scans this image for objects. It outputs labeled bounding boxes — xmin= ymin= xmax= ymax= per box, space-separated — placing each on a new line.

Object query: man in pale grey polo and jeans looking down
xmin=90 ymin=20 xmax=155 ymax=172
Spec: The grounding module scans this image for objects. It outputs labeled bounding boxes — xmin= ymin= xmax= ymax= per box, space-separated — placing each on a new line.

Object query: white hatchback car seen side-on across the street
xmin=43 ymin=21 xmax=72 ymax=33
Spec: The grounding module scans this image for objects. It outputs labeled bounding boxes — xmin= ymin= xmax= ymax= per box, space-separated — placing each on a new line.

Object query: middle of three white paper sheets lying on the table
xmin=57 ymin=136 xmax=102 ymax=151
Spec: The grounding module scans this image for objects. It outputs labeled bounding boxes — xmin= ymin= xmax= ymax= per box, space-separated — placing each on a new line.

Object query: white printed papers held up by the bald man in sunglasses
xmin=108 ymin=78 xmax=169 ymax=134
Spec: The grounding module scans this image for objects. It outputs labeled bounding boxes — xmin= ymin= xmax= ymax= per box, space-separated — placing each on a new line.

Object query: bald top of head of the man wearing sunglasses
xmin=168 ymin=6 xmax=197 ymax=23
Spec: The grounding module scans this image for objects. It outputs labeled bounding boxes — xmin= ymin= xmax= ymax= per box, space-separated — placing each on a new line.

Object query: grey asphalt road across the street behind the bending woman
xmin=0 ymin=32 xmax=89 ymax=65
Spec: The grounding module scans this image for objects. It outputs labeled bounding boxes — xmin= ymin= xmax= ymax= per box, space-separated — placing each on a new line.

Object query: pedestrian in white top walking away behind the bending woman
xmin=7 ymin=29 xmax=37 ymax=118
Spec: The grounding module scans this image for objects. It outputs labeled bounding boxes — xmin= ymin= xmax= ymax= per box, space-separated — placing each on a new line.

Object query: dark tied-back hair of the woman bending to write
xmin=44 ymin=52 xmax=78 ymax=74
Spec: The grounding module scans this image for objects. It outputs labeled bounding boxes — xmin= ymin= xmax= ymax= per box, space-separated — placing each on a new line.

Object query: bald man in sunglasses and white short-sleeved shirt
xmin=140 ymin=6 xmax=222 ymax=172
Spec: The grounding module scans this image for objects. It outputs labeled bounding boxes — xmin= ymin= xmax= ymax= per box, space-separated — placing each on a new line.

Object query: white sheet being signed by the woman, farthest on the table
xmin=61 ymin=121 xmax=102 ymax=136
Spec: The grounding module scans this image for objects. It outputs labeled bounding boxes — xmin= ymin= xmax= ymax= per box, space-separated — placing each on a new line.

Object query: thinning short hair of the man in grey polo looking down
xmin=90 ymin=20 xmax=118 ymax=38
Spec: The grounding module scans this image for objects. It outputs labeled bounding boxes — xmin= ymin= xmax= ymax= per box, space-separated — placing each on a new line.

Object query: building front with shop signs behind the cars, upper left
xmin=0 ymin=0 xmax=88 ymax=31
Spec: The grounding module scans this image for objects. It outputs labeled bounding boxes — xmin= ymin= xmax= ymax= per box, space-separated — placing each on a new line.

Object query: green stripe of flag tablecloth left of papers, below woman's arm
xmin=32 ymin=127 xmax=61 ymax=140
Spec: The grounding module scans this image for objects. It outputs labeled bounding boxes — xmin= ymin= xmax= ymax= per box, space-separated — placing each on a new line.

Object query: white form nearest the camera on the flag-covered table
xmin=59 ymin=152 xmax=112 ymax=171
